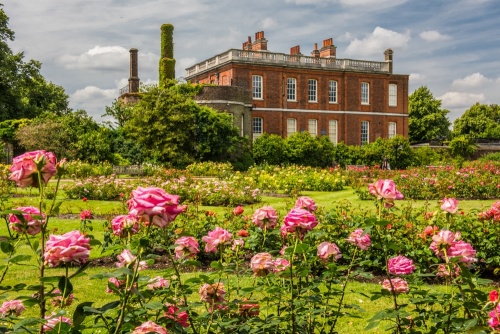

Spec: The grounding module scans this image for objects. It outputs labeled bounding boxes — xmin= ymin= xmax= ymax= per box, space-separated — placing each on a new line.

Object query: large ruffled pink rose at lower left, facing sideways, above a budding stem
xmin=43 ymin=231 xmax=90 ymax=267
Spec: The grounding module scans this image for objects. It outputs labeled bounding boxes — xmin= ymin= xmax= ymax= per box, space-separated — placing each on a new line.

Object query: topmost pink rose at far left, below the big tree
xmin=9 ymin=150 xmax=57 ymax=188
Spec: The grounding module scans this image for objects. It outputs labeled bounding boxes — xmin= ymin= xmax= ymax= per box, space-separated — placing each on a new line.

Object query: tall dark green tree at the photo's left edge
xmin=0 ymin=4 xmax=68 ymax=121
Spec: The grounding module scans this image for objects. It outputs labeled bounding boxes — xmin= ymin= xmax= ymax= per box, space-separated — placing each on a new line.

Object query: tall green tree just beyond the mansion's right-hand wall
xmin=408 ymin=86 xmax=451 ymax=143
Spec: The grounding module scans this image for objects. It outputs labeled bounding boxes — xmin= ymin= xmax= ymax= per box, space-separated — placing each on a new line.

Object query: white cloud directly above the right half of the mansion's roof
xmin=346 ymin=27 xmax=411 ymax=56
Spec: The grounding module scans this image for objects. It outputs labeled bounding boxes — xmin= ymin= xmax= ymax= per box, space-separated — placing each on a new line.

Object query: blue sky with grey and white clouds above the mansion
xmin=0 ymin=0 xmax=500 ymax=122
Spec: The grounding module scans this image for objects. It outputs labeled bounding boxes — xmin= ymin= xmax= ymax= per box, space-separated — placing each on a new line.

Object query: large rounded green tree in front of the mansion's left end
xmin=124 ymin=80 xmax=249 ymax=167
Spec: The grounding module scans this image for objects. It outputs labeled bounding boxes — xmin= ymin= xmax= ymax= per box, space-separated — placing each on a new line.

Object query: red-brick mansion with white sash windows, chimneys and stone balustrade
xmin=186 ymin=31 xmax=409 ymax=145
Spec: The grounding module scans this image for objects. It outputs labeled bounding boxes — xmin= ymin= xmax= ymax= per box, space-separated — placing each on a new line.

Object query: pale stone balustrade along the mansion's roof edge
xmin=186 ymin=49 xmax=389 ymax=79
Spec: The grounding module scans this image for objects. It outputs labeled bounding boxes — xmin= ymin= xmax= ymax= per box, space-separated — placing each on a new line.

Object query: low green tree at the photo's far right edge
xmin=452 ymin=103 xmax=500 ymax=139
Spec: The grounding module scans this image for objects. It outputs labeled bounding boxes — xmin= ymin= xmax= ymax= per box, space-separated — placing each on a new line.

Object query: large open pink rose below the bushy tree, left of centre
xmin=127 ymin=187 xmax=186 ymax=228
